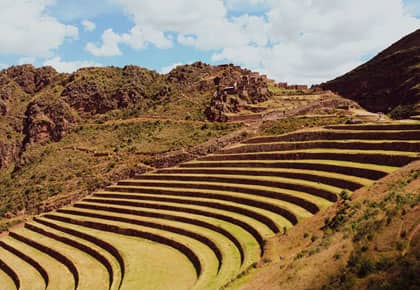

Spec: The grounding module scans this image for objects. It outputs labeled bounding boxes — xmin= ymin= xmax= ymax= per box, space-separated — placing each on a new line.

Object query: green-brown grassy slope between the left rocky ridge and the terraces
xmin=0 ymin=121 xmax=240 ymax=229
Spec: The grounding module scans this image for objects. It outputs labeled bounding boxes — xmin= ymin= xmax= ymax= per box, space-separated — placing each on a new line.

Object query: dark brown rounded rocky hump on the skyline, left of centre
xmin=61 ymin=66 xmax=170 ymax=115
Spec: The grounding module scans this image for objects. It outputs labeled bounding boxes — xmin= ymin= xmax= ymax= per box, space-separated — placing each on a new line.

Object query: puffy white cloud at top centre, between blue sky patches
xmin=86 ymin=0 xmax=268 ymax=56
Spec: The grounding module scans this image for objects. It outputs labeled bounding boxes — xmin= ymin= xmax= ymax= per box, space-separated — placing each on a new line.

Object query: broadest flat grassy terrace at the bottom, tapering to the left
xmin=37 ymin=215 xmax=196 ymax=290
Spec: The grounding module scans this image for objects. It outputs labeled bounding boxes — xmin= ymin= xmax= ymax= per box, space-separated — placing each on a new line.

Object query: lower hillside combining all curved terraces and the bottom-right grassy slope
xmin=0 ymin=120 xmax=420 ymax=290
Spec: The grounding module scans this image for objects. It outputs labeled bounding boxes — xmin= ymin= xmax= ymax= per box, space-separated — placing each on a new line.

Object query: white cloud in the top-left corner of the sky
xmin=0 ymin=0 xmax=78 ymax=57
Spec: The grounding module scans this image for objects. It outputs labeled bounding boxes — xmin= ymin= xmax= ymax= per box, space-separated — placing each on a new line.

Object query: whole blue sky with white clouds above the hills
xmin=0 ymin=0 xmax=420 ymax=84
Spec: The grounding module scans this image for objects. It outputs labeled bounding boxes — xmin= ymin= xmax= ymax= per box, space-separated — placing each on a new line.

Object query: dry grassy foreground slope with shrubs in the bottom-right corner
xmin=235 ymin=161 xmax=420 ymax=290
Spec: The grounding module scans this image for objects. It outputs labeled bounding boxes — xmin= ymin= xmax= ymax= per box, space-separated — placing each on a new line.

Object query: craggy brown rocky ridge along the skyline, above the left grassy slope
xmin=0 ymin=62 xmax=269 ymax=169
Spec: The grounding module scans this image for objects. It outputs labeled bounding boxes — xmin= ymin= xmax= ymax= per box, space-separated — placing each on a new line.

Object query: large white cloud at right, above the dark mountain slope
xmin=213 ymin=0 xmax=420 ymax=84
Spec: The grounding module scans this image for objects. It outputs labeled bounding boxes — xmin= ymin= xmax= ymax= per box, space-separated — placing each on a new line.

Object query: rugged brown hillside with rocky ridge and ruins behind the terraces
xmin=0 ymin=62 xmax=348 ymax=231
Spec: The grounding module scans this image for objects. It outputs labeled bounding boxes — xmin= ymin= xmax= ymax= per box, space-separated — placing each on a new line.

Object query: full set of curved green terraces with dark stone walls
xmin=0 ymin=122 xmax=420 ymax=290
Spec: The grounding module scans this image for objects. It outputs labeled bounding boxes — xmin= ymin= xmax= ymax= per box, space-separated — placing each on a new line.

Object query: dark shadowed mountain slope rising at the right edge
xmin=321 ymin=29 xmax=420 ymax=113
